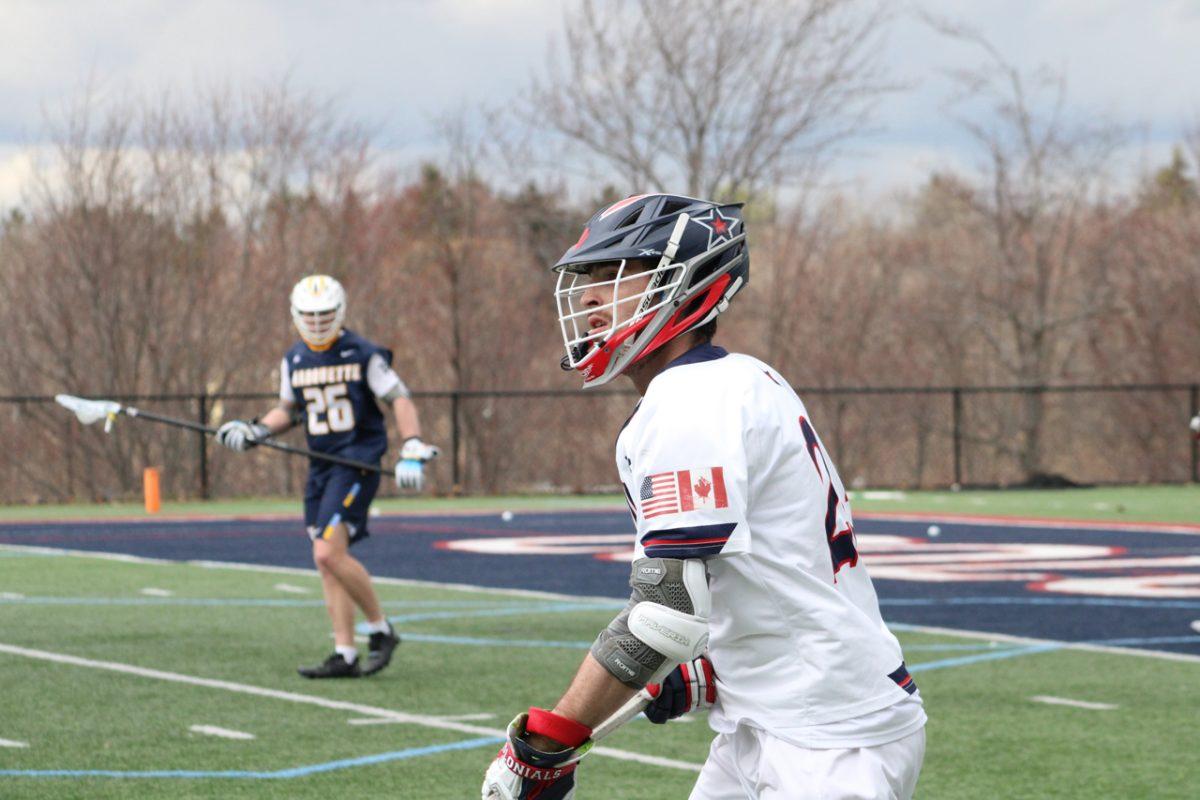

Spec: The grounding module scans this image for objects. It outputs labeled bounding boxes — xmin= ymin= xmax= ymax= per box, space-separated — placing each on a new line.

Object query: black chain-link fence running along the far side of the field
xmin=0 ymin=384 xmax=1200 ymax=504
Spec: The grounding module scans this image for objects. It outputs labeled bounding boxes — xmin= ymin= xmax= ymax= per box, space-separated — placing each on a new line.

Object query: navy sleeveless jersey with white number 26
xmin=283 ymin=330 xmax=391 ymax=463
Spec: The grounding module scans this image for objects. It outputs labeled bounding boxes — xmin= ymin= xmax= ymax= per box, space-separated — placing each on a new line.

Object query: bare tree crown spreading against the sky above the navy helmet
xmin=526 ymin=0 xmax=888 ymax=197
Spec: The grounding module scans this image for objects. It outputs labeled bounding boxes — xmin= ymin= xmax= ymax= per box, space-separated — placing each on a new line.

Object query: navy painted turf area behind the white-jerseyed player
xmin=0 ymin=511 xmax=1200 ymax=655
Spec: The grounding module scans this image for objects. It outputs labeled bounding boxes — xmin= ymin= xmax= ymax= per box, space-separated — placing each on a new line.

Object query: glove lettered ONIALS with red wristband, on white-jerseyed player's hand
xmin=482 ymin=709 xmax=592 ymax=800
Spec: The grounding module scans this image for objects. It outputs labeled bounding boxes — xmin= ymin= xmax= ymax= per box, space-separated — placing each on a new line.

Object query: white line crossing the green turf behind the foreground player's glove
xmin=0 ymin=643 xmax=700 ymax=772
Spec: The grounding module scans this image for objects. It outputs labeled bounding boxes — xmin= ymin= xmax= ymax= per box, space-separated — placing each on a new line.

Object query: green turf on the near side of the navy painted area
xmin=0 ymin=548 xmax=1200 ymax=800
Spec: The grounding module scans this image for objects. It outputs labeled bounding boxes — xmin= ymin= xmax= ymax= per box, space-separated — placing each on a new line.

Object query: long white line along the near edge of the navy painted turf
xmin=0 ymin=545 xmax=1200 ymax=663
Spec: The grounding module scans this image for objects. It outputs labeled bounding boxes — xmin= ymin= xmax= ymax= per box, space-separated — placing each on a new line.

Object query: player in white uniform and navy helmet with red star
xmin=484 ymin=194 xmax=925 ymax=800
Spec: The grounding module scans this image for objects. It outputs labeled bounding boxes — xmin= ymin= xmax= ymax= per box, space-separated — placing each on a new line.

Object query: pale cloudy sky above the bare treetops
xmin=0 ymin=0 xmax=1200 ymax=206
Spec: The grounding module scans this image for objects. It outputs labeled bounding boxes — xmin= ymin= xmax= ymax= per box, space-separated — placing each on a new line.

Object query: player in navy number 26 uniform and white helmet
xmin=217 ymin=275 xmax=438 ymax=678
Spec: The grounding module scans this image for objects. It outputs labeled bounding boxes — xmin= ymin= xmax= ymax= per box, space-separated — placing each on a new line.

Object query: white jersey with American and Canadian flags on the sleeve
xmin=617 ymin=345 xmax=925 ymax=747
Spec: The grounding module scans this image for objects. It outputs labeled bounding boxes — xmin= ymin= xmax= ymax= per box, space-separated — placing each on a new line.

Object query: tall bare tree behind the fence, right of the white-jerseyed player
xmin=916 ymin=23 xmax=1127 ymax=480
